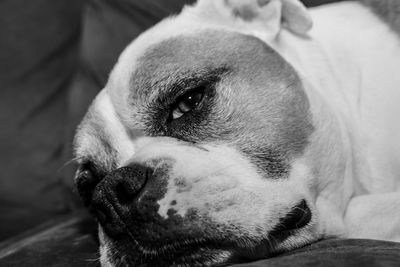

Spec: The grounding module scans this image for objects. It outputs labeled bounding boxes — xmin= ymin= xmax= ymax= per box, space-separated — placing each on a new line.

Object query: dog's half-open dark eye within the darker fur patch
xmin=172 ymin=87 xmax=204 ymax=120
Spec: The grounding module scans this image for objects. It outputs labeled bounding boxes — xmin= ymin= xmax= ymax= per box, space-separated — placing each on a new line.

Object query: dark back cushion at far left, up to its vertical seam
xmin=0 ymin=0 xmax=83 ymax=240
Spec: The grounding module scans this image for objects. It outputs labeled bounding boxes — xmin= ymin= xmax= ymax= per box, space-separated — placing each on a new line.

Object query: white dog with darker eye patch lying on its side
xmin=74 ymin=0 xmax=400 ymax=266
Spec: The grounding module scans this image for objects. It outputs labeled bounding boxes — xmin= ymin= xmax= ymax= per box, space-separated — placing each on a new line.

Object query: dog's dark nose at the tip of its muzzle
xmin=92 ymin=164 xmax=153 ymax=237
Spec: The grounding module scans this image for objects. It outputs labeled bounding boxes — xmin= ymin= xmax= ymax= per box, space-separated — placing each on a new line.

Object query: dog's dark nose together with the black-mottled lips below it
xmin=83 ymin=163 xmax=234 ymax=266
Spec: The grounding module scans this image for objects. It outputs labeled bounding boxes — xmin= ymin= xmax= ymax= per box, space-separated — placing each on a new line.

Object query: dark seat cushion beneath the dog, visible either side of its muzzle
xmin=0 ymin=213 xmax=400 ymax=267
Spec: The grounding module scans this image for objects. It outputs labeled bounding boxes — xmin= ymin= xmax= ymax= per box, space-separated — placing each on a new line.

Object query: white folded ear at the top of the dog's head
xmin=199 ymin=0 xmax=312 ymax=41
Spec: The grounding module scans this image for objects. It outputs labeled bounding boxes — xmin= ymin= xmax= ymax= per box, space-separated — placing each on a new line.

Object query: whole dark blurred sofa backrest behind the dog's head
xmin=0 ymin=0 xmax=335 ymax=243
